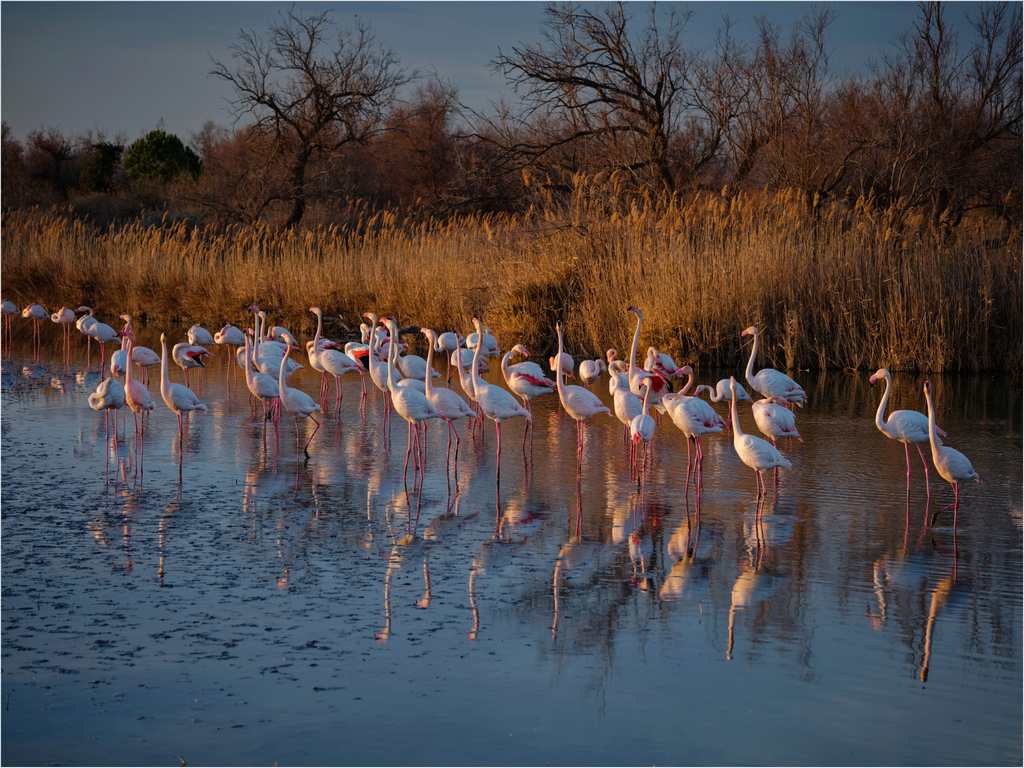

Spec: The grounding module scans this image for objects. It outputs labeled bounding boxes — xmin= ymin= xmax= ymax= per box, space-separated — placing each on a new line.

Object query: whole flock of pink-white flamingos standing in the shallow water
xmin=2 ymin=300 xmax=981 ymax=530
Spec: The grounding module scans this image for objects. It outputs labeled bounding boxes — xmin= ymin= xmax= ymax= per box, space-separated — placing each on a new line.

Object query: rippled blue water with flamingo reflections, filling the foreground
xmin=2 ymin=328 xmax=1022 ymax=765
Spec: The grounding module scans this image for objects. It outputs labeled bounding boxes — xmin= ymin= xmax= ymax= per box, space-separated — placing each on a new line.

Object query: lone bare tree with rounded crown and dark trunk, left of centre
xmin=210 ymin=8 xmax=413 ymax=227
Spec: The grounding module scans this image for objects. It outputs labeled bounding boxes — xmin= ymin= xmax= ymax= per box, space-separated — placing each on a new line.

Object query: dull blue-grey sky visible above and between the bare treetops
xmin=0 ymin=0 xmax=965 ymax=143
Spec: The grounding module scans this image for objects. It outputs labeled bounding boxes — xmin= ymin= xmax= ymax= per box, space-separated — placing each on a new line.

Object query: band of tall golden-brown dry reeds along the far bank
xmin=2 ymin=179 xmax=1024 ymax=371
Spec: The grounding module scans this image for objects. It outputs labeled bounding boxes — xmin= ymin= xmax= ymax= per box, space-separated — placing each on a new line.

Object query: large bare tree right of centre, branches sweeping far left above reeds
xmin=476 ymin=2 xmax=689 ymax=190
